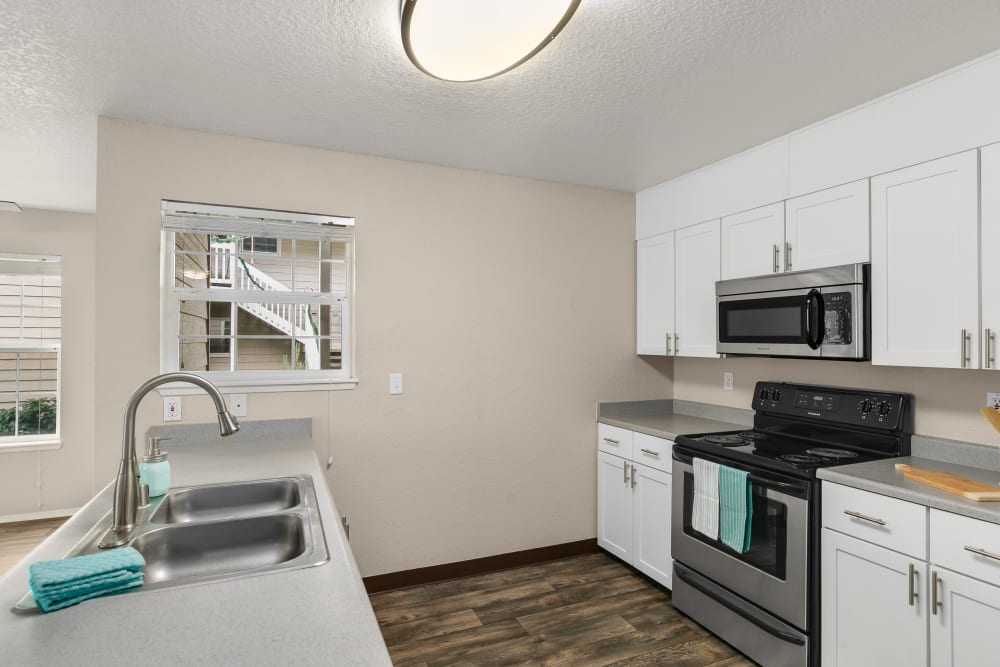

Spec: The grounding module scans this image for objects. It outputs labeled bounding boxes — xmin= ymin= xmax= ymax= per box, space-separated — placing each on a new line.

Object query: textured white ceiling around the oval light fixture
xmin=0 ymin=0 xmax=1000 ymax=210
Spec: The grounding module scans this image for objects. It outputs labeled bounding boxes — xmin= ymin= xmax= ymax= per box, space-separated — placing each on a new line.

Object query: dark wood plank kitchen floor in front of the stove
xmin=371 ymin=554 xmax=754 ymax=667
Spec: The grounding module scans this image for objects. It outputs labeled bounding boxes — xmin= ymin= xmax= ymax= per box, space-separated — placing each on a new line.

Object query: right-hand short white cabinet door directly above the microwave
xmin=785 ymin=179 xmax=871 ymax=271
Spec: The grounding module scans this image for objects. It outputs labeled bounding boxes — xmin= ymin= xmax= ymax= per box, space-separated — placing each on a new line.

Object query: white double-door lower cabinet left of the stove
xmin=597 ymin=433 xmax=673 ymax=588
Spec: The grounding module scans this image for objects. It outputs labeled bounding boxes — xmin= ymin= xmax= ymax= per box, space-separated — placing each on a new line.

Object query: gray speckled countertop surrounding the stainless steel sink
xmin=0 ymin=426 xmax=391 ymax=667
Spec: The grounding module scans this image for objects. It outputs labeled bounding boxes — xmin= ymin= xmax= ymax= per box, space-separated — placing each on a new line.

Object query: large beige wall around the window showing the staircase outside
xmin=95 ymin=119 xmax=671 ymax=575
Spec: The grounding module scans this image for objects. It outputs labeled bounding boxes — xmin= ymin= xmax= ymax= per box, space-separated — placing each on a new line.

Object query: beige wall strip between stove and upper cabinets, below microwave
xmin=674 ymin=358 xmax=1000 ymax=444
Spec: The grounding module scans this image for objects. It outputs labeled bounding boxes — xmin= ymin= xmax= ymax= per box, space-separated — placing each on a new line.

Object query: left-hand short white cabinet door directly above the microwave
xmin=722 ymin=202 xmax=785 ymax=280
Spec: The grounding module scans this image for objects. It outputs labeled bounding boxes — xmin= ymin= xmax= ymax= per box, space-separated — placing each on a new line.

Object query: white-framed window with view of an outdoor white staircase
xmin=161 ymin=201 xmax=354 ymax=380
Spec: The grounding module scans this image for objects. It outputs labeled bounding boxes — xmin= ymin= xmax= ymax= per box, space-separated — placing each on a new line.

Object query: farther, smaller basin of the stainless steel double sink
xmin=150 ymin=479 xmax=302 ymax=523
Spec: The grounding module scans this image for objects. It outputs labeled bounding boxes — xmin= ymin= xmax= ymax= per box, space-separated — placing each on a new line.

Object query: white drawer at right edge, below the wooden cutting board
xmin=931 ymin=509 xmax=1000 ymax=584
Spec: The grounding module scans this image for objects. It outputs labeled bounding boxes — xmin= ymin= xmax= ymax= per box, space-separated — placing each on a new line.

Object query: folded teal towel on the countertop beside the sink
xmin=28 ymin=547 xmax=146 ymax=612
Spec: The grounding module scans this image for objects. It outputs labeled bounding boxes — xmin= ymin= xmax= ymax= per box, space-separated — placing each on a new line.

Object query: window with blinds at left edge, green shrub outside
xmin=0 ymin=254 xmax=62 ymax=448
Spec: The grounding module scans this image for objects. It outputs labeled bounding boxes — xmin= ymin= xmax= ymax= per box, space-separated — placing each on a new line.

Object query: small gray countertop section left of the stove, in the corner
xmin=597 ymin=400 xmax=753 ymax=440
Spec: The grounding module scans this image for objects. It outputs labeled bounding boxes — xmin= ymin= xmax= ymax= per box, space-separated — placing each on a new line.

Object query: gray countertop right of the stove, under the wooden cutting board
xmin=816 ymin=456 xmax=1000 ymax=523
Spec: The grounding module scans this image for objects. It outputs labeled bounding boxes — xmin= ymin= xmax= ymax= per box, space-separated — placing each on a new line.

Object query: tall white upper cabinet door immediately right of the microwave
xmin=871 ymin=150 xmax=979 ymax=368
